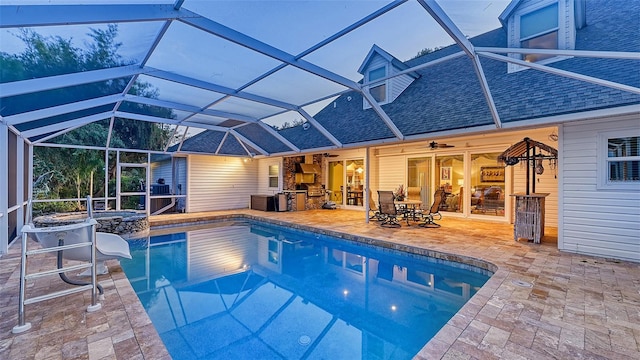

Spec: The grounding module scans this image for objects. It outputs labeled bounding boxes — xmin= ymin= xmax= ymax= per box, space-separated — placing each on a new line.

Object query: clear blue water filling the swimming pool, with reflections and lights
xmin=121 ymin=222 xmax=489 ymax=359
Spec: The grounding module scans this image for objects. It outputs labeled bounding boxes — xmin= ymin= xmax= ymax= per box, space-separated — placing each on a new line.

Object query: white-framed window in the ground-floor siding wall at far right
xmin=598 ymin=130 xmax=640 ymax=189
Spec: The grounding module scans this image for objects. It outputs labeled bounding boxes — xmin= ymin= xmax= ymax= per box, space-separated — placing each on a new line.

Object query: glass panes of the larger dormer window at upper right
xmin=520 ymin=3 xmax=558 ymax=62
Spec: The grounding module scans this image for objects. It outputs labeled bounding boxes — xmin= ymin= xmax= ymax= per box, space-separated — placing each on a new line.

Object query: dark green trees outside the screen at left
xmin=0 ymin=25 xmax=175 ymax=211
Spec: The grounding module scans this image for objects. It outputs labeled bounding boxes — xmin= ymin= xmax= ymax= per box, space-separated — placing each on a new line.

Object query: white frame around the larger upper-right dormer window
xmin=507 ymin=0 xmax=576 ymax=73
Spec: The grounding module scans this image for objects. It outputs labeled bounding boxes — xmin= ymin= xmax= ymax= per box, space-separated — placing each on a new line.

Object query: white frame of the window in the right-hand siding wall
xmin=596 ymin=128 xmax=640 ymax=191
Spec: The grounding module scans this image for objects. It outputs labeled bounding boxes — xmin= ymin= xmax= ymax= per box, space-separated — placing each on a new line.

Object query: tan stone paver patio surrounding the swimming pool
xmin=0 ymin=210 xmax=640 ymax=360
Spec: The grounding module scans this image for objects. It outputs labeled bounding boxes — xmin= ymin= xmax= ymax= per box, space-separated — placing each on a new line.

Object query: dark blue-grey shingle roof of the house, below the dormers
xmin=302 ymin=1 xmax=640 ymax=144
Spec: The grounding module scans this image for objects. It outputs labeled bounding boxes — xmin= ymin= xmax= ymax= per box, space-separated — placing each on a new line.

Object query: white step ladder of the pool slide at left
xmin=12 ymin=219 xmax=102 ymax=334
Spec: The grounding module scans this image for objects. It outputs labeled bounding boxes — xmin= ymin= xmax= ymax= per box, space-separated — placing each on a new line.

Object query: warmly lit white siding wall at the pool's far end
xmin=187 ymin=155 xmax=258 ymax=212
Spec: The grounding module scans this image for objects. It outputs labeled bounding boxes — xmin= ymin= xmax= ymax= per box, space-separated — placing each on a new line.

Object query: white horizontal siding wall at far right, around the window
xmin=558 ymin=115 xmax=640 ymax=261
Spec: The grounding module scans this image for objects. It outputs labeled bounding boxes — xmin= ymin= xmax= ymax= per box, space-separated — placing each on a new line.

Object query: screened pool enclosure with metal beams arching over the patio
xmin=0 ymin=0 xmax=640 ymax=253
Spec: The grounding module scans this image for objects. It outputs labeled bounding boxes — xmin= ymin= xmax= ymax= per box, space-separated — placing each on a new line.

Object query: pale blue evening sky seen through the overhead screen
xmin=0 ymin=0 xmax=509 ymax=127
